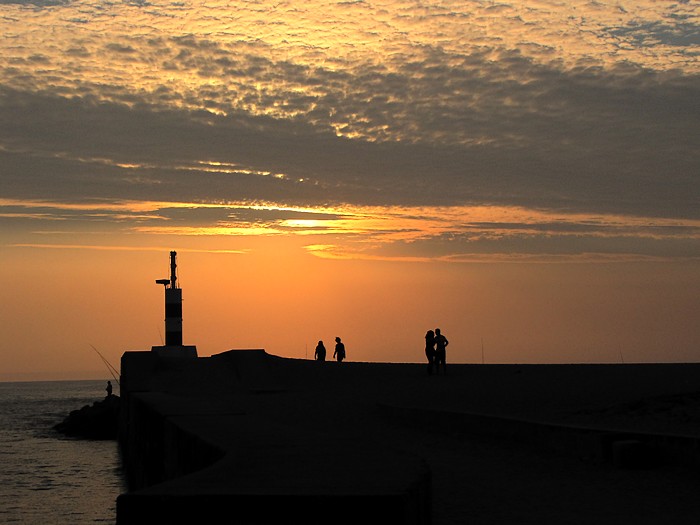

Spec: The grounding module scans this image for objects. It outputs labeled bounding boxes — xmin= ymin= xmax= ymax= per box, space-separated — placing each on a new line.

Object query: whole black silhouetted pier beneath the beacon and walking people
xmin=117 ymin=350 xmax=700 ymax=525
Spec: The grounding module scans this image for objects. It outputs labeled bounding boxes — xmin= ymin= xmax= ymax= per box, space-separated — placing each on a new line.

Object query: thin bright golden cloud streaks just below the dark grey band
xmin=0 ymin=199 xmax=700 ymax=262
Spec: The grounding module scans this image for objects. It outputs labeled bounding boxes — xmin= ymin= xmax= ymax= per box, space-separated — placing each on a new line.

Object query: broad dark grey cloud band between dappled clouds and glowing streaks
xmin=0 ymin=75 xmax=700 ymax=217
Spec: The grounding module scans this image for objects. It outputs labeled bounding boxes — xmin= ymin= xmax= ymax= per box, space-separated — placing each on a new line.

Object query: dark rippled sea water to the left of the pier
xmin=0 ymin=380 xmax=126 ymax=525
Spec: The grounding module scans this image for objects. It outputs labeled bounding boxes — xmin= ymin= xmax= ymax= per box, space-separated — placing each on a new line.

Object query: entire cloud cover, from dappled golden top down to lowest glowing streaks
xmin=0 ymin=0 xmax=700 ymax=262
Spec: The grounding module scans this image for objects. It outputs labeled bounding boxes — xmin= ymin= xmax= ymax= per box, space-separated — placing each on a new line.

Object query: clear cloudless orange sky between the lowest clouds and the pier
xmin=0 ymin=239 xmax=700 ymax=380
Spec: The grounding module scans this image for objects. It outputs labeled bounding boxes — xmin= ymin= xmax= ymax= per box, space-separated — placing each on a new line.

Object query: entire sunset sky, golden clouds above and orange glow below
xmin=0 ymin=0 xmax=700 ymax=380
